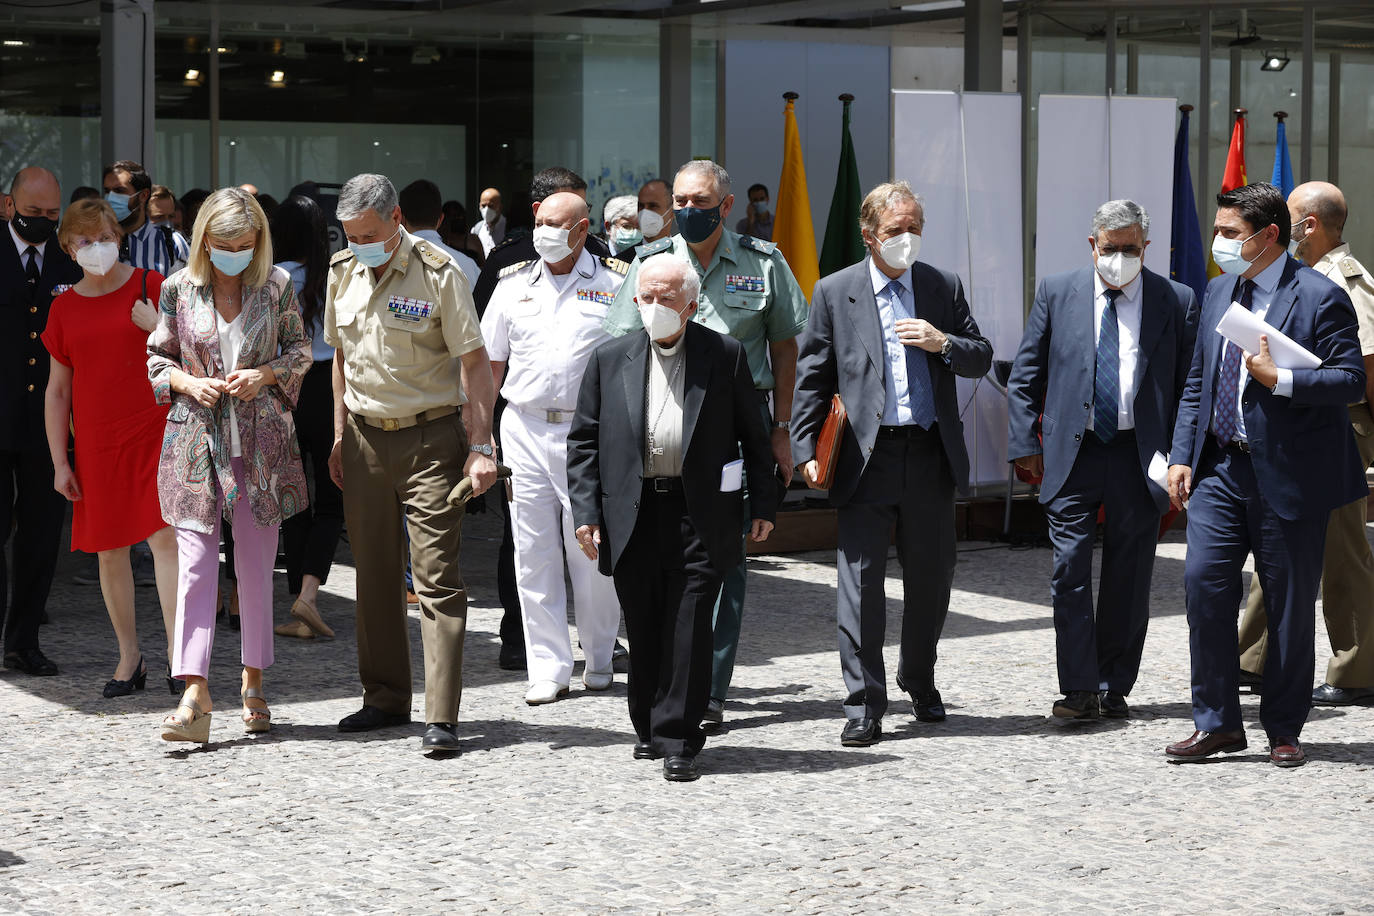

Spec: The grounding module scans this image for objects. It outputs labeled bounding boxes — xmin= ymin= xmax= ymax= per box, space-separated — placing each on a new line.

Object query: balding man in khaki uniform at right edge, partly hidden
xmin=1241 ymin=181 xmax=1374 ymax=706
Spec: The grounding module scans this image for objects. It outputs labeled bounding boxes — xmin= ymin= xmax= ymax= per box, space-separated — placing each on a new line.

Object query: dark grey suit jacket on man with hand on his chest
xmin=791 ymin=258 xmax=992 ymax=505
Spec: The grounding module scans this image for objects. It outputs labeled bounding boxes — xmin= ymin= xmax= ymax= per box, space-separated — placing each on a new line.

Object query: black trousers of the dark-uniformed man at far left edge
xmin=0 ymin=449 xmax=67 ymax=652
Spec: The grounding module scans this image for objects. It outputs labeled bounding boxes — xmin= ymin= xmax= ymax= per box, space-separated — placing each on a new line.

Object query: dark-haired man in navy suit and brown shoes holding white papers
xmin=1164 ymin=184 xmax=1366 ymax=766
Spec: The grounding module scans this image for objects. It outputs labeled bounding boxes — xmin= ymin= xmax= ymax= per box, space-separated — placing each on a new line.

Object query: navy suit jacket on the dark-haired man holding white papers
xmin=1171 ymin=254 xmax=1369 ymax=520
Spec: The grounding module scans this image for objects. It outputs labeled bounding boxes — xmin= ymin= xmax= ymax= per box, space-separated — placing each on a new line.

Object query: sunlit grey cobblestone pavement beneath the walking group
xmin=0 ymin=515 xmax=1374 ymax=913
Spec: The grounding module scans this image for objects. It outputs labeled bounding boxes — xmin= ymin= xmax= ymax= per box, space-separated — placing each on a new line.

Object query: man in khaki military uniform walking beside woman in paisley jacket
xmin=324 ymin=174 xmax=496 ymax=751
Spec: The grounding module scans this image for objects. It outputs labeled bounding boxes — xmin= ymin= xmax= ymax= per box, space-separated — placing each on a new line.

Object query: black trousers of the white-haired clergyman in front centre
xmin=603 ymin=485 xmax=721 ymax=757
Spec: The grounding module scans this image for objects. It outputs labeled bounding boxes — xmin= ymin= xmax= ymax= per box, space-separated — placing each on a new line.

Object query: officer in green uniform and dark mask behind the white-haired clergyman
xmin=605 ymin=159 xmax=807 ymax=724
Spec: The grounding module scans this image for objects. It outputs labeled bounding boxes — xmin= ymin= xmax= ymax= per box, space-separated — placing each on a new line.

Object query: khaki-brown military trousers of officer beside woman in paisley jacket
xmin=342 ymin=412 xmax=467 ymax=722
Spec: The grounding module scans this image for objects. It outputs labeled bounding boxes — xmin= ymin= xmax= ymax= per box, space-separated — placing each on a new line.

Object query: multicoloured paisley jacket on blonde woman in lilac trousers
xmin=148 ymin=266 xmax=311 ymax=534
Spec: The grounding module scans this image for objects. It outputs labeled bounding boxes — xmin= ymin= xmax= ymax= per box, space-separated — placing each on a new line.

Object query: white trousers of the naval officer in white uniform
xmin=502 ymin=404 xmax=620 ymax=685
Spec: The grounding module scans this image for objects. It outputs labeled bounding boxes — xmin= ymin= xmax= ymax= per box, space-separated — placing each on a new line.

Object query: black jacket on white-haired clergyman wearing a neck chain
xmin=567 ymin=321 xmax=778 ymax=575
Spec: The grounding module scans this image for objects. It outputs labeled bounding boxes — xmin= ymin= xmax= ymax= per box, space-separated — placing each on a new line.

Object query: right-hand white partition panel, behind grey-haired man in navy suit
xmin=1035 ymin=95 xmax=1178 ymax=280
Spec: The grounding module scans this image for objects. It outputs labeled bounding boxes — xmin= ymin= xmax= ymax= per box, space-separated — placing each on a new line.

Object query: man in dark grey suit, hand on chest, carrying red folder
xmin=791 ymin=181 xmax=992 ymax=747
